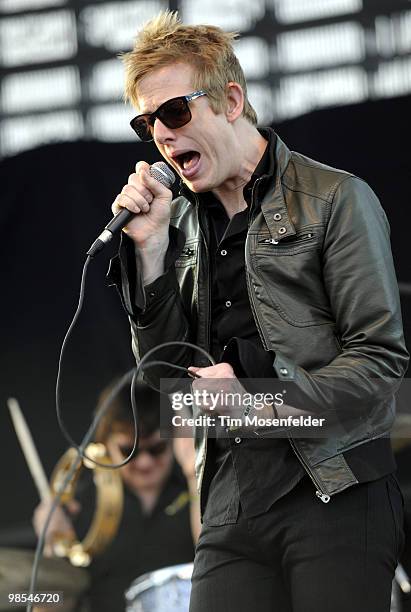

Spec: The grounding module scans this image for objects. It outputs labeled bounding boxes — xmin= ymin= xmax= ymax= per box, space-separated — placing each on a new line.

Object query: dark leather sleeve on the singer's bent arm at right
xmin=274 ymin=176 xmax=409 ymax=426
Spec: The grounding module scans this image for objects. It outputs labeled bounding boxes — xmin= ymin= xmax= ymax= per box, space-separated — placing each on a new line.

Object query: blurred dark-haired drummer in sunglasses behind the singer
xmin=33 ymin=383 xmax=200 ymax=612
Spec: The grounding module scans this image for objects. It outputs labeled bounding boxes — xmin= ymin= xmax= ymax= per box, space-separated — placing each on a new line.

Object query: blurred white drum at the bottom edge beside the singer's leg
xmin=125 ymin=563 xmax=193 ymax=612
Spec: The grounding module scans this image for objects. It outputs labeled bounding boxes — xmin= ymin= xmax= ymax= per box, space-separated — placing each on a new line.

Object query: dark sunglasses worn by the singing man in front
xmin=130 ymin=89 xmax=207 ymax=142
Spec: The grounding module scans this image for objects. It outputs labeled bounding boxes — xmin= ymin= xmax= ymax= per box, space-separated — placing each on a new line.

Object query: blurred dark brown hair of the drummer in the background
xmin=95 ymin=380 xmax=173 ymax=443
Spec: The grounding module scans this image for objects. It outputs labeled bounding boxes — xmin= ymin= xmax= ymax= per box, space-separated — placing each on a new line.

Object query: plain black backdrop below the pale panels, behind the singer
xmin=0 ymin=97 xmax=411 ymax=545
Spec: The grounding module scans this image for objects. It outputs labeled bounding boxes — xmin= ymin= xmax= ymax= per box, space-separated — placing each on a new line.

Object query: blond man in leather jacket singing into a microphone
xmin=108 ymin=12 xmax=408 ymax=612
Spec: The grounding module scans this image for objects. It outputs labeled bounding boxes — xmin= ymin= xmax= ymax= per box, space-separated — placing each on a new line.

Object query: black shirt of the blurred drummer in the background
xmin=75 ymin=464 xmax=194 ymax=612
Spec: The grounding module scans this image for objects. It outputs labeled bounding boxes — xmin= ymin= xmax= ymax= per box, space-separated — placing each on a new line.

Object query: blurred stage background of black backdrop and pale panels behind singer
xmin=0 ymin=0 xmax=411 ymax=604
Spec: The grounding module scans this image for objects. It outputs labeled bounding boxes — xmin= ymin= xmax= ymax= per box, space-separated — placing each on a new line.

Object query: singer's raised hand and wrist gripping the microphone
xmin=111 ymin=161 xmax=172 ymax=254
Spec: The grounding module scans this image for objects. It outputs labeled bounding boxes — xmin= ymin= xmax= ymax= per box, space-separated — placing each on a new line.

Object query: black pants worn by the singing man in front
xmin=190 ymin=476 xmax=404 ymax=612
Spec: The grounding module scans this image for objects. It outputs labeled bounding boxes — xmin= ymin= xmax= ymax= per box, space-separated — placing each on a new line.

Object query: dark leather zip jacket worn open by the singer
xmin=112 ymin=129 xmax=408 ymax=501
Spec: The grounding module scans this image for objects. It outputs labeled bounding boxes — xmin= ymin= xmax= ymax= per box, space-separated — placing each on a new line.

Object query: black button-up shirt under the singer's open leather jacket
xmin=200 ymin=132 xmax=304 ymax=525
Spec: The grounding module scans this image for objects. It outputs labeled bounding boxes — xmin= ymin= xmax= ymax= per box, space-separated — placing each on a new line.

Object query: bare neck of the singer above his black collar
xmin=212 ymin=121 xmax=267 ymax=219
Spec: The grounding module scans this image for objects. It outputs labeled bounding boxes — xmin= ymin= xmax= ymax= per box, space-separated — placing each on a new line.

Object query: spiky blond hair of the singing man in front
xmin=122 ymin=11 xmax=257 ymax=125
